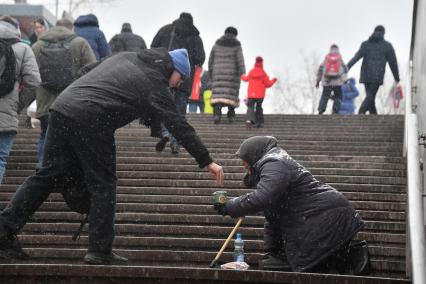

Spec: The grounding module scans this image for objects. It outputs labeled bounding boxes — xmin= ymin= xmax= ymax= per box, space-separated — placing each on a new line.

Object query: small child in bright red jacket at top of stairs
xmin=241 ymin=56 xmax=277 ymax=128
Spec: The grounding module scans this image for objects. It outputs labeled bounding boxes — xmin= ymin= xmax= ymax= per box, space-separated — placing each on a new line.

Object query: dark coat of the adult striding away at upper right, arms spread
xmin=347 ymin=32 xmax=399 ymax=85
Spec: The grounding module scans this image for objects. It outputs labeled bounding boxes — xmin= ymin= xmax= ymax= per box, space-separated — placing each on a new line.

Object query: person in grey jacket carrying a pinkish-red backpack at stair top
xmin=315 ymin=44 xmax=348 ymax=114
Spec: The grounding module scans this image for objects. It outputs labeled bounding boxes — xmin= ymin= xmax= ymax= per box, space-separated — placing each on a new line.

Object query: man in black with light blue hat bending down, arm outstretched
xmin=0 ymin=48 xmax=224 ymax=265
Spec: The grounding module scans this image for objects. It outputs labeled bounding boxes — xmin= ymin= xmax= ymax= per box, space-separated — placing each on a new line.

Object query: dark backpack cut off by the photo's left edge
xmin=0 ymin=39 xmax=19 ymax=97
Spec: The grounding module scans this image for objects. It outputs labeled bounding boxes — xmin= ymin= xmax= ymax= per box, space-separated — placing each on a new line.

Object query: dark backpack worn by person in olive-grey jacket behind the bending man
xmin=38 ymin=35 xmax=76 ymax=92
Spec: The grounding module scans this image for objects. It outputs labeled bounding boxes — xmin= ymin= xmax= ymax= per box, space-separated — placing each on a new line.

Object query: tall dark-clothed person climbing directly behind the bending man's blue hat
xmin=151 ymin=12 xmax=206 ymax=154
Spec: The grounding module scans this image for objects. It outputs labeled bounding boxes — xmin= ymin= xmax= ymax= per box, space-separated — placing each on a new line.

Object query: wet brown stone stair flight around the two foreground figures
xmin=0 ymin=114 xmax=410 ymax=284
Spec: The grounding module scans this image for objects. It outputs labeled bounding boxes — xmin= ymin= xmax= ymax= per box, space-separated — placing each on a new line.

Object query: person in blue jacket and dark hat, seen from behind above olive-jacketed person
xmin=74 ymin=14 xmax=111 ymax=60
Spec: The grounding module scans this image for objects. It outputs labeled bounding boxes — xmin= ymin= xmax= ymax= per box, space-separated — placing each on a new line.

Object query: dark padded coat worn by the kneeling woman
xmin=226 ymin=143 xmax=363 ymax=271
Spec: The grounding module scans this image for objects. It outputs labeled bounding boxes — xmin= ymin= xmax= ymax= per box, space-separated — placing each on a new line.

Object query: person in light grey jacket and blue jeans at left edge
xmin=0 ymin=16 xmax=40 ymax=184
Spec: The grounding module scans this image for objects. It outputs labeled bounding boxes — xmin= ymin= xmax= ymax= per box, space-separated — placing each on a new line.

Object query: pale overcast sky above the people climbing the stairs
xmin=10 ymin=0 xmax=413 ymax=77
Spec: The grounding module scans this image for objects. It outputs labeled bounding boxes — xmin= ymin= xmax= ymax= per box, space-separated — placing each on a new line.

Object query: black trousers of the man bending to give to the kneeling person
xmin=0 ymin=112 xmax=117 ymax=254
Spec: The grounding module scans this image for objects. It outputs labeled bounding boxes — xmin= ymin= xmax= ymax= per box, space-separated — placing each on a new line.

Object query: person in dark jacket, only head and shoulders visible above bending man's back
xmin=109 ymin=23 xmax=146 ymax=53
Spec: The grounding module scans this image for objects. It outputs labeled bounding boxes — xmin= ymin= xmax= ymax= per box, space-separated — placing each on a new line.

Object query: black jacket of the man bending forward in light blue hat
xmin=51 ymin=48 xmax=212 ymax=167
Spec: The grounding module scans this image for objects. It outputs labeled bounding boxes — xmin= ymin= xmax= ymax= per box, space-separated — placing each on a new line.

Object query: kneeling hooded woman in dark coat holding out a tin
xmin=215 ymin=136 xmax=368 ymax=274
